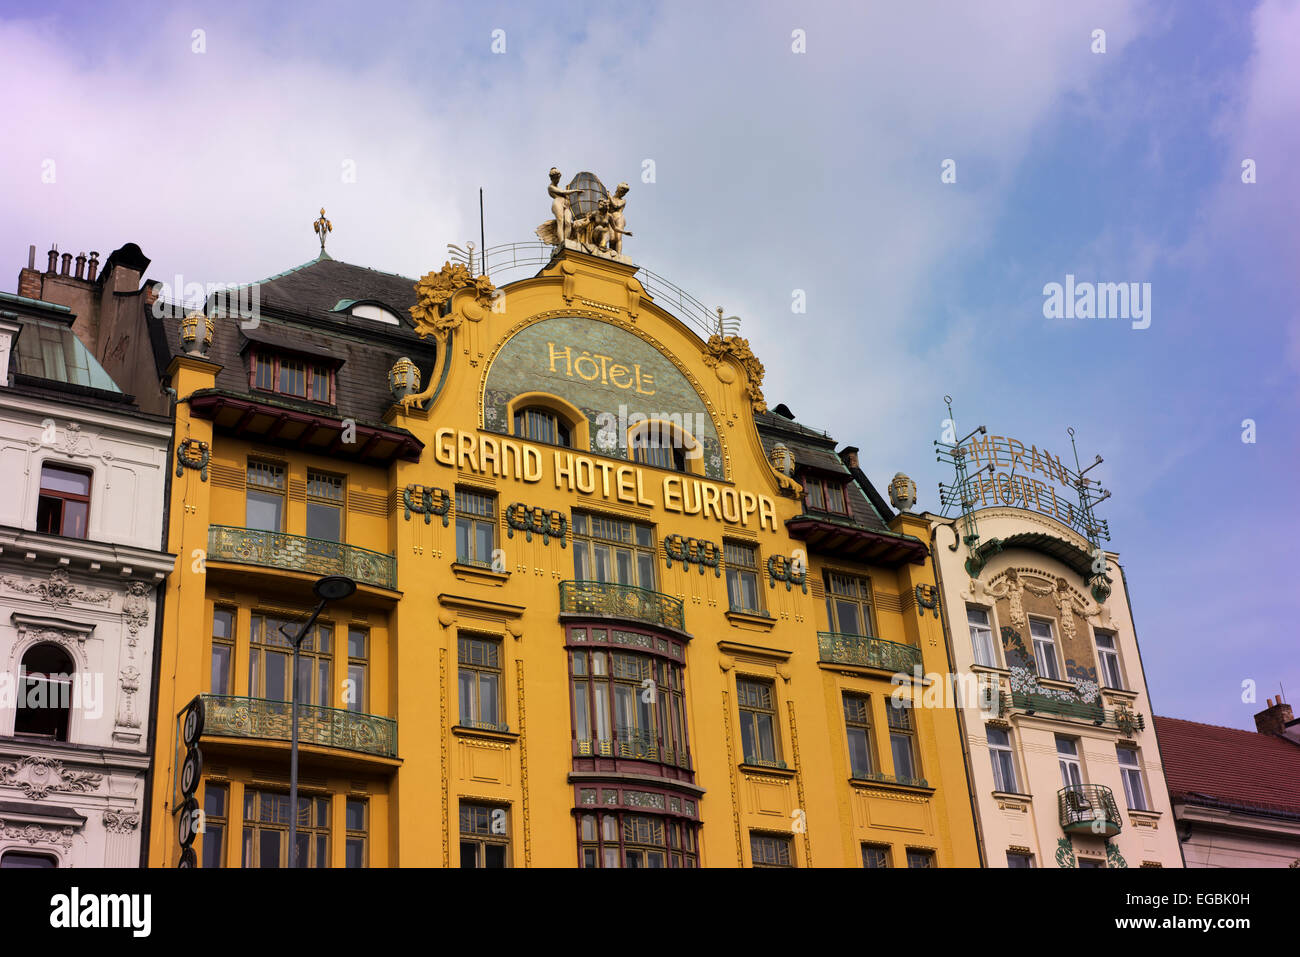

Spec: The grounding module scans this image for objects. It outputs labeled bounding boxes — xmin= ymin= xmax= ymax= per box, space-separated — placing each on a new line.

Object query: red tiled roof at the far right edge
xmin=1156 ymin=716 xmax=1300 ymax=814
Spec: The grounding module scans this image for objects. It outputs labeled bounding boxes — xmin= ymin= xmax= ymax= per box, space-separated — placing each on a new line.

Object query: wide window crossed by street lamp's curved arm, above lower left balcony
xmin=248 ymin=614 xmax=334 ymax=707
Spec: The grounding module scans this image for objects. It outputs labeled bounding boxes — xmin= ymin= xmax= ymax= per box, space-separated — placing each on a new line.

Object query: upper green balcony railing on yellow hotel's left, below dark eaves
xmin=208 ymin=525 xmax=398 ymax=590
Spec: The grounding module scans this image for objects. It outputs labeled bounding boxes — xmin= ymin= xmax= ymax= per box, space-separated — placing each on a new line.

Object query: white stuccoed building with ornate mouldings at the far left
xmin=0 ymin=293 xmax=174 ymax=869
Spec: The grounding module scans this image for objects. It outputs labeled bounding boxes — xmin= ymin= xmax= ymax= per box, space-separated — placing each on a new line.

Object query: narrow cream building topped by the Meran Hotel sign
xmin=920 ymin=426 xmax=1182 ymax=867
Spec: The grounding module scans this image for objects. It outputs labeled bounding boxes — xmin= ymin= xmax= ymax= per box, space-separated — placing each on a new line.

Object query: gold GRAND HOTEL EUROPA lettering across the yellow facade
xmin=433 ymin=428 xmax=776 ymax=532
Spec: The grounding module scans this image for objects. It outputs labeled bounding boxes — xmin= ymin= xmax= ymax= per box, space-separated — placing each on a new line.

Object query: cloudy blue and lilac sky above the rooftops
xmin=0 ymin=0 xmax=1300 ymax=728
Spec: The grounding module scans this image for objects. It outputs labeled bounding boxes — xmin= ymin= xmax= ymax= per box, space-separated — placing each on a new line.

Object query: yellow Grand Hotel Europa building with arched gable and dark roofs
xmin=131 ymin=184 xmax=980 ymax=867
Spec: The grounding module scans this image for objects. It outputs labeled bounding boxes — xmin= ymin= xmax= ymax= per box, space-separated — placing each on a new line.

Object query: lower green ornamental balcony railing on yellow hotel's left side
xmin=202 ymin=694 xmax=398 ymax=758
